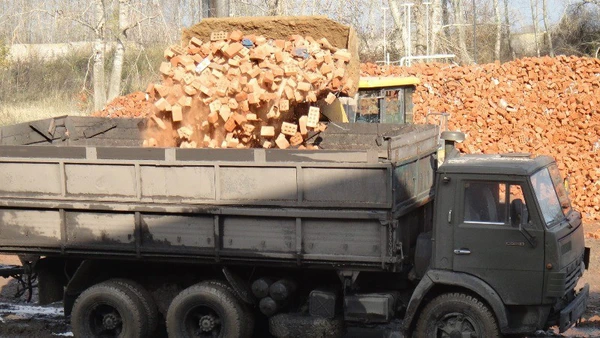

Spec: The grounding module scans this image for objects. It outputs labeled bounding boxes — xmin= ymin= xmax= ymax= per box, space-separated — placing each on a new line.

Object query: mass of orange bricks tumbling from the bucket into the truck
xmin=144 ymin=31 xmax=352 ymax=149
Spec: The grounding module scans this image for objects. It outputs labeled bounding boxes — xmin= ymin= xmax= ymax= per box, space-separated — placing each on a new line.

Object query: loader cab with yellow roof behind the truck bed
xmin=321 ymin=76 xmax=421 ymax=124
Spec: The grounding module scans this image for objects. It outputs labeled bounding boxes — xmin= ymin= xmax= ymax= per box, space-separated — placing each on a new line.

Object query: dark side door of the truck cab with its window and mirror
xmin=453 ymin=180 xmax=544 ymax=305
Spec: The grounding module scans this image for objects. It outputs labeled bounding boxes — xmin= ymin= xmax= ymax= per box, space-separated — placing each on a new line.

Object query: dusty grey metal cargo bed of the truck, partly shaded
xmin=0 ymin=117 xmax=438 ymax=269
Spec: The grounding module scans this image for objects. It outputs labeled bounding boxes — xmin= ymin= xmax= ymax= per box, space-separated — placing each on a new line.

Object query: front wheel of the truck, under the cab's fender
xmin=413 ymin=293 xmax=501 ymax=338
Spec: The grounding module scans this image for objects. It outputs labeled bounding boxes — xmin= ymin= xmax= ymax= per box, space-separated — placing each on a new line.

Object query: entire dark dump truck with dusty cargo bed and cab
xmin=0 ymin=117 xmax=589 ymax=337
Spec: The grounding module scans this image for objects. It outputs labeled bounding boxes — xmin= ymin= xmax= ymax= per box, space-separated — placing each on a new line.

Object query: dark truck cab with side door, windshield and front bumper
xmin=407 ymin=142 xmax=589 ymax=336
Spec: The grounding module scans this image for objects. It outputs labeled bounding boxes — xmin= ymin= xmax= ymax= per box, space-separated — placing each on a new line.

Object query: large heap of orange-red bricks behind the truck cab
xmin=361 ymin=56 xmax=600 ymax=220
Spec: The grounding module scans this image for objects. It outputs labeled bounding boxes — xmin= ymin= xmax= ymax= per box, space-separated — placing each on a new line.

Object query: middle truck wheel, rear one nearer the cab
xmin=167 ymin=283 xmax=246 ymax=338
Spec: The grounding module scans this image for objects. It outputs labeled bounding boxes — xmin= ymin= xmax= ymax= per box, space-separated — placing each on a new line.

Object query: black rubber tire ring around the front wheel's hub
xmin=413 ymin=292 xmax=502 ymax=338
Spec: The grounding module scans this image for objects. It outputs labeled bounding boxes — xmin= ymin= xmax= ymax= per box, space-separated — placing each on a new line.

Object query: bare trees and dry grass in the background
xmin=0 ymin=0 xmax=600 ymax=124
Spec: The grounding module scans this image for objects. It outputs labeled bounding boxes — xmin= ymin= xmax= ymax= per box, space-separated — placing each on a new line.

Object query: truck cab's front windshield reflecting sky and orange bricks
xmin=531 ymin=165 xmax=571 ymax=227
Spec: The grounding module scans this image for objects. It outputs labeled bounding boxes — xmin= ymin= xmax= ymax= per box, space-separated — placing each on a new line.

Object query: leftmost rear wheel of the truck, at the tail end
xmin=71 ymin=282 xmax=148 ymax=338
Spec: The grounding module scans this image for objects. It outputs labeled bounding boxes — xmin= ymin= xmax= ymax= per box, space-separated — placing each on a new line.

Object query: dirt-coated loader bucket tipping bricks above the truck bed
xmin=182 ymin=16 xmax=360 ymax=96
